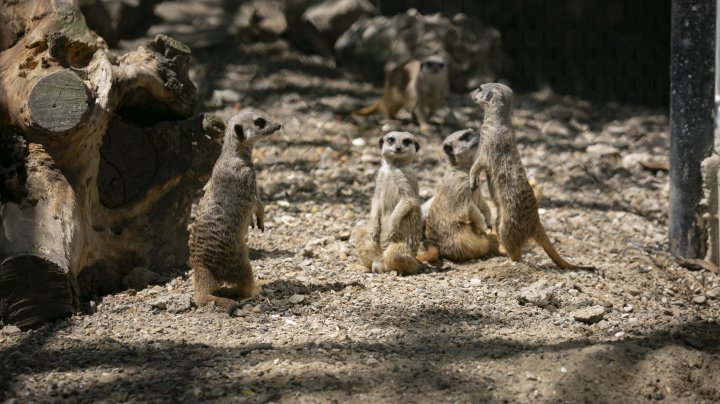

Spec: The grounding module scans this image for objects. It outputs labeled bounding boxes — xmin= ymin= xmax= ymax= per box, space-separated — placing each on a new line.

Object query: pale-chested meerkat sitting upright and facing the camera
xmin=353 ymin=132 xmax=422 ymax=275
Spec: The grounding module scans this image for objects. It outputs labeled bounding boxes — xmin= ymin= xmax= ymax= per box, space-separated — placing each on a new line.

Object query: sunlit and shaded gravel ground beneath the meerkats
xmin=0 ymin=35 xmax=720 ymax=403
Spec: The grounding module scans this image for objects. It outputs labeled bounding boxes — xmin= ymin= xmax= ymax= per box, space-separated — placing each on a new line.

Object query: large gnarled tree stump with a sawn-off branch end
xmin=0 ymin=0 xmax=224 ymax=328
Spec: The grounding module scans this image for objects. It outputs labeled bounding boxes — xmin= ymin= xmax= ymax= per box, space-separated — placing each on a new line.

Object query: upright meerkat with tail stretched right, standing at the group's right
xmin=469 ymin=83 xmax=595 ymax=270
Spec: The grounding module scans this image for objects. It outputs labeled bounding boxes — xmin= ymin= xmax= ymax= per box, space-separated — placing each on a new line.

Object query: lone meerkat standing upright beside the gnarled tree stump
xmin=188 ymin=111 xmax=280 ymax=309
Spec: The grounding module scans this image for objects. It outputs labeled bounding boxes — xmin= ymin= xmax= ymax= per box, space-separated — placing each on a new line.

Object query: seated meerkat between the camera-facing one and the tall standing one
xmin=418 ymin=129 xmax=498 ymax=261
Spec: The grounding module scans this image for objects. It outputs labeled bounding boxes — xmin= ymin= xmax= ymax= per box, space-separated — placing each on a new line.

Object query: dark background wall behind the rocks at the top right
xmin=372 ymin=0 xmax=668 ymax=106
